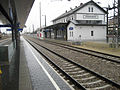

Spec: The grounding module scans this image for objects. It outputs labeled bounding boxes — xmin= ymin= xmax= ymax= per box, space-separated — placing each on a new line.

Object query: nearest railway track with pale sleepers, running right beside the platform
xmin=27 ymin=37 xmax=120 ymax=90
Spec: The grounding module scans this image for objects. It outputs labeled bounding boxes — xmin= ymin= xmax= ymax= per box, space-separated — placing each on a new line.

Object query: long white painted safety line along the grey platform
xmin=25 ymin=40 xmax=60 ymax=90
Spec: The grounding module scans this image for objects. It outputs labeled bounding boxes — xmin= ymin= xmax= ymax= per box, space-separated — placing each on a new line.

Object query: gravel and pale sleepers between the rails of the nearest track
xmin=26 ymin=38 xmax=118 ymax=90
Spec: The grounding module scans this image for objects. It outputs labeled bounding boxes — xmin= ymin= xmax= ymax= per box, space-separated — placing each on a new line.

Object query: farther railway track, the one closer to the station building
xmin=38 ymin=39 xmax=120 ymax=64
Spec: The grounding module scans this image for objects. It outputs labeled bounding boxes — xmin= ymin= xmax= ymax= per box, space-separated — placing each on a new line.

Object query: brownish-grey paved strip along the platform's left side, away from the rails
xmin=19 ymin=38 xmax=32 ymax=90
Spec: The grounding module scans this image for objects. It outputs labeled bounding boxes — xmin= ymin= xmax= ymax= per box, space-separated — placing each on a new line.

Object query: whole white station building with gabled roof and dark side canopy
xmin=44 ymin=0 xmax=107 ymax=41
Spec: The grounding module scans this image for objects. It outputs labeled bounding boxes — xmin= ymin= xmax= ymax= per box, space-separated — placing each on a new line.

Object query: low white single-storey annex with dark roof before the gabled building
xmin=67 ymin=20 xmax=106 ymax=41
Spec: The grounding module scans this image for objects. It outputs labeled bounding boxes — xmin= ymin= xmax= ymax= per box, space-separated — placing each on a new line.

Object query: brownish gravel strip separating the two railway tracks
xmin=24 ymin=37 xmax=120 ymax=84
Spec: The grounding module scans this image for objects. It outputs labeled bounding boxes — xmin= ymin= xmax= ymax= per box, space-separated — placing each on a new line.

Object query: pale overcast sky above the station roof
xmin=25 ymin=0 xmax=114 ymax=31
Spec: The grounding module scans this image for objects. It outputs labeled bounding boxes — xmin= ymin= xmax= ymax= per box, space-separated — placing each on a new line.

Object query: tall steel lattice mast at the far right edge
xmin=108 ymin=0 xmax=120 ymax=48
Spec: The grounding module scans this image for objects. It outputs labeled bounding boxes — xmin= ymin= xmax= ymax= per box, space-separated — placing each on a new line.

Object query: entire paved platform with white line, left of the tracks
xmin=19 ymin=37 xmax=73 ymax=90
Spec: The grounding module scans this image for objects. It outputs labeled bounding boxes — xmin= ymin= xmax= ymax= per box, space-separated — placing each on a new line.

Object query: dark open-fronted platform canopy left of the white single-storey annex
xmin=44 ymin=23 xmax=67 ymax=40
